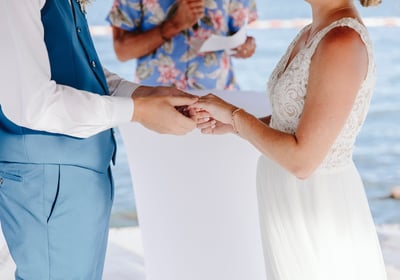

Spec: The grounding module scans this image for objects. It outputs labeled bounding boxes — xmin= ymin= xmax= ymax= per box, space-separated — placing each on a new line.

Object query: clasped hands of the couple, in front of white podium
xmin=132 ymin=86 xmax=241 ymax=135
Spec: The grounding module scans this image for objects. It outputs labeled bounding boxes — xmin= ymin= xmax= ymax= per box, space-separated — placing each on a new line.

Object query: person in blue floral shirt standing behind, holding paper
xmin=107 ymin=0 xmax=257 ymax=90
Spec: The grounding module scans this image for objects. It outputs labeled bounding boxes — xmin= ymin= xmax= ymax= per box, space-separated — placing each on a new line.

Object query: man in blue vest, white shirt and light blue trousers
xmin=0 ymin=0 xmax=197 ymax=280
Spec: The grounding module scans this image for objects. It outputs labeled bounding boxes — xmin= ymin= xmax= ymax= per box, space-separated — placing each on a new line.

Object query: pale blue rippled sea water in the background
xmin=87 ymin=0 xmax=400 ymax=227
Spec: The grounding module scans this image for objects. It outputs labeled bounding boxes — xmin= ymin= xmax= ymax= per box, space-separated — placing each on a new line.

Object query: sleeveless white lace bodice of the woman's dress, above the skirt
xmin=268 ymin=18 xmax=375 ymax=169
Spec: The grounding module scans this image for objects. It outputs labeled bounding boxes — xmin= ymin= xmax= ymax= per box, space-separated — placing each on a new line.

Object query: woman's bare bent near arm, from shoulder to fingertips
xmin=195 ymin=28 xmax=368 ymax=178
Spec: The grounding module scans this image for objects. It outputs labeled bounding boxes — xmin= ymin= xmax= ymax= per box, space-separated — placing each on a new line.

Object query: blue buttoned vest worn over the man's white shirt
xmin=0 ymin=0 xmax=115 ymax=171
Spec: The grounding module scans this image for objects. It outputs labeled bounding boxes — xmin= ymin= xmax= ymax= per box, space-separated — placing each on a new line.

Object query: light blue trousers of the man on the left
xmin=0 ymin=163 xmax=114 ymax=280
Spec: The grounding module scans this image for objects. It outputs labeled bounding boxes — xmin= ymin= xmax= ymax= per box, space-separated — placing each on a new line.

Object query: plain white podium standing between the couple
xmin=120 ymin=91 xmax=270 ymax=280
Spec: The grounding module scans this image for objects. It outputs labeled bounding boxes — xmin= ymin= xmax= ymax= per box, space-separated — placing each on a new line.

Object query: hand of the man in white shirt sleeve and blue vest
xmin=132 ymin=86 xmax=198 ymax=135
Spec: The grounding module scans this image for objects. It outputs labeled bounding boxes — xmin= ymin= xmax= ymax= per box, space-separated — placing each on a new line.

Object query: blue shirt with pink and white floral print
xmin=107 ymin=0 xmax=257 ymax=89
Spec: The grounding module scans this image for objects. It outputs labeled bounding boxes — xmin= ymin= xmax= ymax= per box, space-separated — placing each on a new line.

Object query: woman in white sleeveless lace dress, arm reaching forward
xmin=192 ymin=0 xmax=386 ymax=280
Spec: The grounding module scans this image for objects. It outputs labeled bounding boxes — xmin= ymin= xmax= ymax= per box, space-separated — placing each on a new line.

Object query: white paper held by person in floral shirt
xmin=199 ymin=25 xmax=247 ymax=54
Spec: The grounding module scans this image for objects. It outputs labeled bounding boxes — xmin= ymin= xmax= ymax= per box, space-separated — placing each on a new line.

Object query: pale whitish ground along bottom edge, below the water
xmin=0 ymin=224 xmax=400 ymax=280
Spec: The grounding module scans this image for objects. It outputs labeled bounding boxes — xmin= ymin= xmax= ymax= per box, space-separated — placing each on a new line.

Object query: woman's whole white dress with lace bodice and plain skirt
xmin=257 ymin=18 xmax=386 ymax=280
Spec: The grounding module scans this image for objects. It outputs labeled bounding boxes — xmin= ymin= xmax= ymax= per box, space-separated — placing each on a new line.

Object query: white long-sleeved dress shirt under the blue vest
xmin=0 ymin=0 xmax=139 ymax=138
